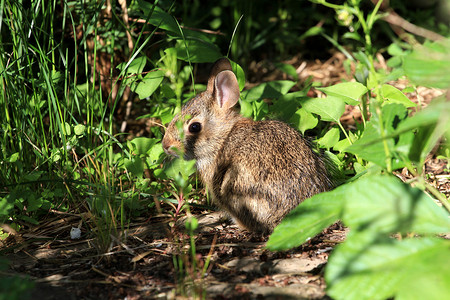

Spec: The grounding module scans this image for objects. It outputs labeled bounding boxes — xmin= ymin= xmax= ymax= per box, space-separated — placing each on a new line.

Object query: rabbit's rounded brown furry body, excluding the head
xmin=207 ymin=119 xmax=332 ymax=233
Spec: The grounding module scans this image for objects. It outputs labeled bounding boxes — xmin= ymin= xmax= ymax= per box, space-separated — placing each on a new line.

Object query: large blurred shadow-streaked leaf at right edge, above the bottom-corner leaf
xmin=342 ymin=175 xmax=450 ymax=234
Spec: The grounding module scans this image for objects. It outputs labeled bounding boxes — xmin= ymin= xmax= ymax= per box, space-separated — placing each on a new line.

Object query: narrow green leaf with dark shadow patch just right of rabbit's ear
xmin=241 ymin=80 xmax=295 ymax=102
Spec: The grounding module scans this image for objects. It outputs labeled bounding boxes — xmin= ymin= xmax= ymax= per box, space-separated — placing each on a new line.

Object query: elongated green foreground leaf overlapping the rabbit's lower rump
xmin=267 ymin=187 xmax=346 ymax=251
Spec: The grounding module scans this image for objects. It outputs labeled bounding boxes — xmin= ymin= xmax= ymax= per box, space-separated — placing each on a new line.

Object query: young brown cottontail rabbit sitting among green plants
xmin=162 ymin=58 xmax=332 ymax=233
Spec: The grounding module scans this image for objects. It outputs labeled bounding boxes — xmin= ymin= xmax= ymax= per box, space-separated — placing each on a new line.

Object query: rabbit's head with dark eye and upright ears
xmin=162 ymin=58 xmax=242 ymax=174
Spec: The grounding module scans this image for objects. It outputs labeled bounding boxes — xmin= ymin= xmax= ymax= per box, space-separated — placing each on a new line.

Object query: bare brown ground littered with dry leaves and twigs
xmin=0 ymin=53 xmax=450 ymax=300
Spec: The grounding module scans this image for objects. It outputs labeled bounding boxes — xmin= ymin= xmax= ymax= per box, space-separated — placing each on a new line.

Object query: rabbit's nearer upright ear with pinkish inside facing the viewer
xmin=214 ymin=70 xmax=239 ymax=109
